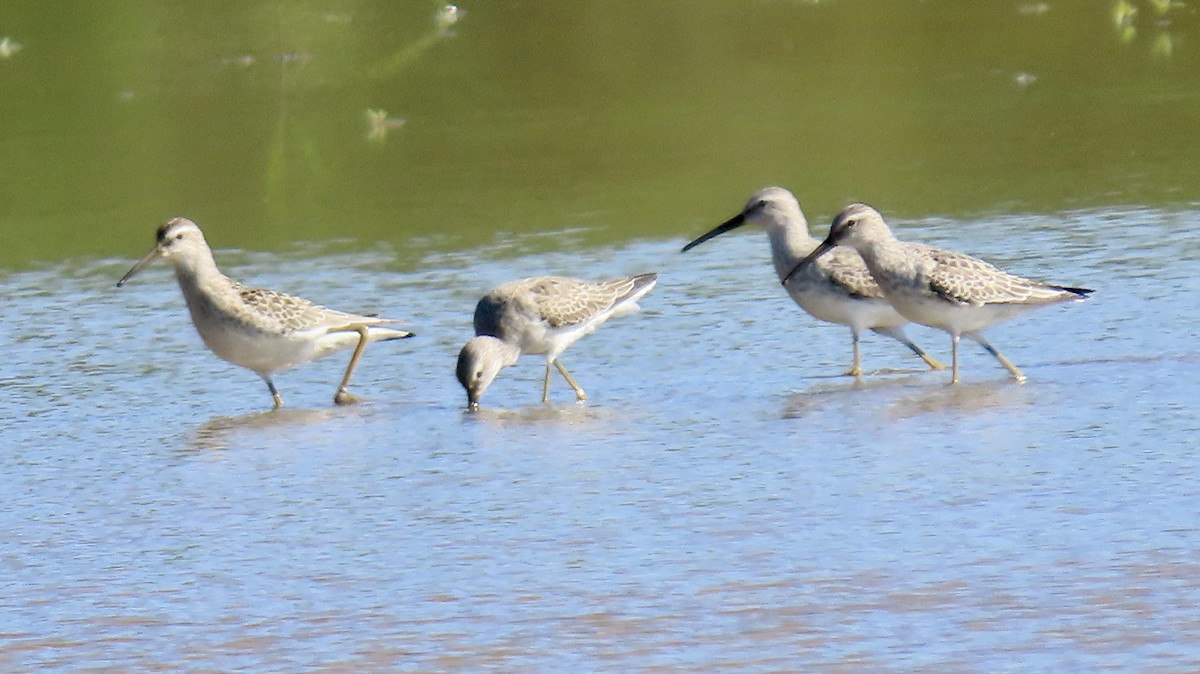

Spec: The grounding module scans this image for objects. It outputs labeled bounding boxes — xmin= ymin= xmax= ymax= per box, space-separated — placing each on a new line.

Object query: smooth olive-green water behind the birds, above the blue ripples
xmin=0 ymin=0 xmax=1200 ymax=267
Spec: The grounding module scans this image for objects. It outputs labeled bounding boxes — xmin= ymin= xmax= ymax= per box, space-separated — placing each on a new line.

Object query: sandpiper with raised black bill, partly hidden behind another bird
xmin=683 ymin=187 xmax=942 ymax=377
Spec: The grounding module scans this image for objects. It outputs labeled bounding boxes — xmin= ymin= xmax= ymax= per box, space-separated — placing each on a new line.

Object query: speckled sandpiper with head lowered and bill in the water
xmin=457 ymin=273 xmax=658 ymax=409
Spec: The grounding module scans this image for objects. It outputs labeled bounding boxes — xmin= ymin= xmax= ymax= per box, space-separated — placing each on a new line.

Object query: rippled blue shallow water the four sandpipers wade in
xmin=0 ymin=210 xmax=1200 ymax=672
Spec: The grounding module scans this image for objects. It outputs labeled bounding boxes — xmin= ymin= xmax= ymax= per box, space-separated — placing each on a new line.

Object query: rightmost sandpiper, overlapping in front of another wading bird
xmin=784 ymin=204 xmax=1092 ymax=384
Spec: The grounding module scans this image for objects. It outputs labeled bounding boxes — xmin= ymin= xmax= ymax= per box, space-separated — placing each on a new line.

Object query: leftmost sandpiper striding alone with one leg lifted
xmin=116 ymin=217 xmax=413 ymax=408
